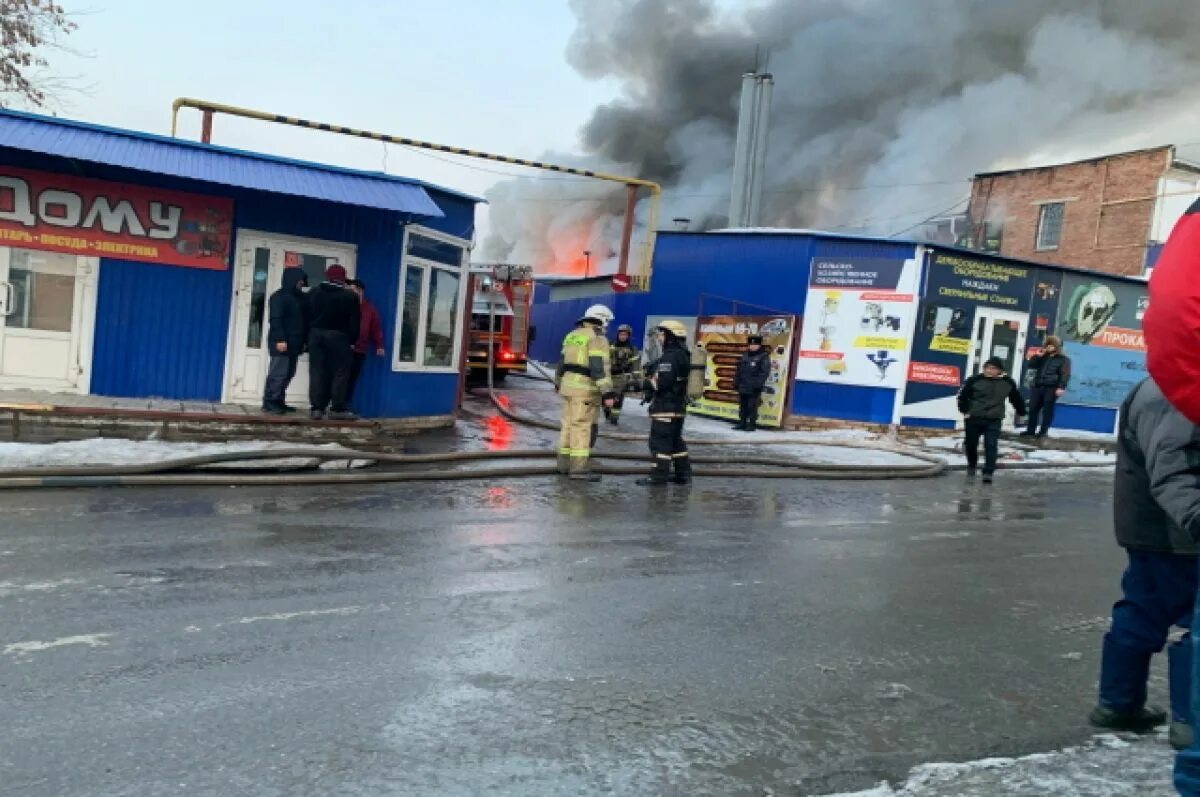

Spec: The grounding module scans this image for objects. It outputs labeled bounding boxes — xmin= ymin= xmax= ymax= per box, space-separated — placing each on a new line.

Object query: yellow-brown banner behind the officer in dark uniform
xmin=691 ymin=316 xmax=796 ymax=427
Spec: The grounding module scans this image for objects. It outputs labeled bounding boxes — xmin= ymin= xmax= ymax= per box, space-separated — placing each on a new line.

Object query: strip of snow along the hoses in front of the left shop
xmin=0 ymin=437 xmax=368 ymax=469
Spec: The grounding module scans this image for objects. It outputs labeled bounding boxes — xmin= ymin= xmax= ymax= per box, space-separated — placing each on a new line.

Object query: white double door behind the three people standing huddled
xmin=224 ymin=230 xmax=355 ymax=405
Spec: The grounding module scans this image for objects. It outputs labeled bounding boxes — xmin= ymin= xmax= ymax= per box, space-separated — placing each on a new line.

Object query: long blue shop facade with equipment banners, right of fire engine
xmin=532 ymin=230 xmax=1147 ymax=433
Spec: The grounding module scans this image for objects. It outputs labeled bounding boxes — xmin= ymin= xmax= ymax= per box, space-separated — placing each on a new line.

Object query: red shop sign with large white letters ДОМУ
xmin=0 ymin=167 xmax=233 ymax=271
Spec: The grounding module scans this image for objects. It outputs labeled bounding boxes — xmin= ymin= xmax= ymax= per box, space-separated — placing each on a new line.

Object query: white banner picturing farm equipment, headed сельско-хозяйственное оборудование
xmin=796 ymin=257 xmax=918 ymax=388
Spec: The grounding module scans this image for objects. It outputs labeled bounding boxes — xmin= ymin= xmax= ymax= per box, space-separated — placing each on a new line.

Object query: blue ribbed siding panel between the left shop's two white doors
xmin=91 ymin=259 xmax=233 ymax=401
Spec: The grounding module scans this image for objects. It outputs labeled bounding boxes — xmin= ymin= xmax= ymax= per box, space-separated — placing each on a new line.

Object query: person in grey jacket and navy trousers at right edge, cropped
xmin=1090 ymin=379 xmax=1200 ymax=749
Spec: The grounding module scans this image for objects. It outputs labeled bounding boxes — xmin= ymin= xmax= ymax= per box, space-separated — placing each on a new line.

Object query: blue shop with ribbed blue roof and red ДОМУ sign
xmin=0 ymin=112 xmax=479 ymax=420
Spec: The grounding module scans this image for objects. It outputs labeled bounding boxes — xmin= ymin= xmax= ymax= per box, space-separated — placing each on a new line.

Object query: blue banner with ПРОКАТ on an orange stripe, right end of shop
xmin=1058 ymin=275 xmax=1148 ymax=407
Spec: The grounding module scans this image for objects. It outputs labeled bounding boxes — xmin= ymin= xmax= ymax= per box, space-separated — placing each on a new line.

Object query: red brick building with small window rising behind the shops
xmin=964 ymin=146 xmax=1200 ymax=276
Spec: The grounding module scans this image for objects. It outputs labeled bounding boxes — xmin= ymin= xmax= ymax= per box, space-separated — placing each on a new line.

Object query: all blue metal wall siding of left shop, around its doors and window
xmin=29 ymin=150 xmax=474 ymax=417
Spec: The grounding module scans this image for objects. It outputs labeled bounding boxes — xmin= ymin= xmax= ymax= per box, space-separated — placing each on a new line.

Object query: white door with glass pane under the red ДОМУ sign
xmin=0 ymin=247 xmax=100 ymax=392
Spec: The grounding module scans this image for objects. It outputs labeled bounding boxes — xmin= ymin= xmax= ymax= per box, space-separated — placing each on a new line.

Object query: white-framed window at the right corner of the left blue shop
xmin=391 ymin=227 xmax=470 ymax=371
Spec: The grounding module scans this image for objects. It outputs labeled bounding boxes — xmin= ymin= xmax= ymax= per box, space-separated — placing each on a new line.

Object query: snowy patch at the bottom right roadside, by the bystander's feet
xmin=827 ymin=735 xmax=1175 ymax=797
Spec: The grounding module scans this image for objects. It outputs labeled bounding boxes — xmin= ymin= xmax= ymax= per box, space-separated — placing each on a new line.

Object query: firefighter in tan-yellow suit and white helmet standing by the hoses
xmin=554 ymin=305 xmax=614 ymax=481
